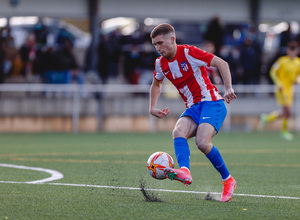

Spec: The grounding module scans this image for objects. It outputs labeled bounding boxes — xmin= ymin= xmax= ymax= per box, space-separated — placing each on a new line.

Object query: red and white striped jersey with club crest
xmin=154 ymin=45 xmax=223 ymax=108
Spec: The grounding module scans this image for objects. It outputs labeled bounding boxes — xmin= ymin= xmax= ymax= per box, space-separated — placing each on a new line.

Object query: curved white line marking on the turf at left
xmin=0 ymin=163 xmax=64 ymax=184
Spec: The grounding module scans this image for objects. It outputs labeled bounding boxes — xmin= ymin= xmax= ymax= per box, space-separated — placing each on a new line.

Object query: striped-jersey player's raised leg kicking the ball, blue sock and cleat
xmin=165 ymin=116 xmax=197 ymax=186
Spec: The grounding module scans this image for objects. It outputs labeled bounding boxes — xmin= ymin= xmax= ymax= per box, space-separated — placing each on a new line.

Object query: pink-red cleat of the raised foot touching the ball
xmin=164 ymin=168 xmax=193 ymax=186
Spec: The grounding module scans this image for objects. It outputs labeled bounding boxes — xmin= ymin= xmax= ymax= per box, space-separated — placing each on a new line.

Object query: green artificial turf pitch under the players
xmin=0 ymin=132 xmax=300 ymax=220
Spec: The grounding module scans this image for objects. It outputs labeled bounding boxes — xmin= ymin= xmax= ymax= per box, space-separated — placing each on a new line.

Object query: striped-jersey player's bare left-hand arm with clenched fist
xmin=149 ymin=79 xmax=170 ymax=118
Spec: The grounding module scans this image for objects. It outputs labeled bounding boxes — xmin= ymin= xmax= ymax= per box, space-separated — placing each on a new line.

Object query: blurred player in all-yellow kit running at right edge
xmin=259 ymin=41 xmax=300 ymax=140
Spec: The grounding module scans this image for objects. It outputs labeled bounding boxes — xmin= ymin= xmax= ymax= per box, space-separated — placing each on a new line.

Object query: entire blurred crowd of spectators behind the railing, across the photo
xmin=0 ymin=17 xmax=300 ymax=89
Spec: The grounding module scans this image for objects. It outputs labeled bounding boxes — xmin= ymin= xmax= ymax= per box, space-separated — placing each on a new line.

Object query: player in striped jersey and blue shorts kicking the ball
xmin=149 ymin=23 xmax=236 ymax=202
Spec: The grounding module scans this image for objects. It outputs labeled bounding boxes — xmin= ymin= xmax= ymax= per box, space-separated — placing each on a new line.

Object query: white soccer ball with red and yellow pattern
xmin=147 ymin=152 xmax=174 ymax=180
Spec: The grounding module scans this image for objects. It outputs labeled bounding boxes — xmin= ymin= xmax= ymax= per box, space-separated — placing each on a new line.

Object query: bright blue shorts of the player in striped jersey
xmin=180 ymin=100 xmax=227 ymax=132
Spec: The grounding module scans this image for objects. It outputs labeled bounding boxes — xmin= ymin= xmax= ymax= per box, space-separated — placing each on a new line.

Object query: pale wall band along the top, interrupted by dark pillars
xmin=0 ymin=0 xmax=300 ymax=22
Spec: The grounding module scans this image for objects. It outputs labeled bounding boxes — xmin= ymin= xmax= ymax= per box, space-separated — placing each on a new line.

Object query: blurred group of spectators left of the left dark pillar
xmin=0 ymin=24 xmax=83 ymax=87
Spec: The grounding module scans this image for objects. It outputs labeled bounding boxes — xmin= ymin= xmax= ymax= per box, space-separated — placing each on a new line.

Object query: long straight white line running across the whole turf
xmin=0 ymin=181 xmax=300 ymax=199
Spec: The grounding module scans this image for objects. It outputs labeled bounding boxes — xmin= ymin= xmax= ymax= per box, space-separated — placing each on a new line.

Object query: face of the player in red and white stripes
xmin=152 ymin=34 xmax=177 ymax=60
